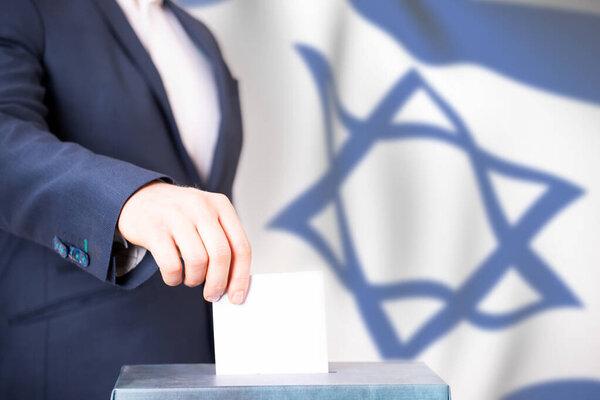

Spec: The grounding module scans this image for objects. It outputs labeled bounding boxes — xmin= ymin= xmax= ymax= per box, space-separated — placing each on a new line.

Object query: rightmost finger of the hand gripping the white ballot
xmin=219 ymin=200 xmax=252 ymax=304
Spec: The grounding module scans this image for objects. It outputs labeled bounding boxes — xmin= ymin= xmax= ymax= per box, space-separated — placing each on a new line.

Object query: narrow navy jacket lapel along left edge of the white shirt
xmin=94 ymin=0 xmax=206 ymax=188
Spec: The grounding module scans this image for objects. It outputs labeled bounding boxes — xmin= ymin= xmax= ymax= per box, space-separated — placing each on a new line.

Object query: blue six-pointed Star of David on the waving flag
xmin=269 ymin=45 xmax=582 ymax=358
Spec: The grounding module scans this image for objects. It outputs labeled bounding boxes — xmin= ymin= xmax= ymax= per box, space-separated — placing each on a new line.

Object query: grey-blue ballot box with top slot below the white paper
xmin=112 ymin=362 xmax=450 ymax=400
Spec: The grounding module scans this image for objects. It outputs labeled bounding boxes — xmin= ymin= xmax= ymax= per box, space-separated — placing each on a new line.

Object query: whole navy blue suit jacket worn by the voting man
xmin=0 ymin=0 xmax=241 ymax=399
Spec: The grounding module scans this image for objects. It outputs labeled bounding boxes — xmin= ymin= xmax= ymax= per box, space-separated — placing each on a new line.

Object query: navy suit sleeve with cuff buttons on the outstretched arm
xmin=0 ymin=0 xmax=166 ymax=288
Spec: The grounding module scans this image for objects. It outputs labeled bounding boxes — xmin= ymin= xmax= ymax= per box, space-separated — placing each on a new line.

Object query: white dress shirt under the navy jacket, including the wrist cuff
xmin=115 ymin=0 xmax=221 ymax=276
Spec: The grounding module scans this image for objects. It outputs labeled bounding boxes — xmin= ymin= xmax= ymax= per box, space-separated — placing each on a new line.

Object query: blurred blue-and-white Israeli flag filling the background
xmin=180 ymin=0 xmax=600 ymax=400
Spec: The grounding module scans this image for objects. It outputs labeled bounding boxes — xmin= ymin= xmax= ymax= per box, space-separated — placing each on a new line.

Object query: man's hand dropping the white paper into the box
xmin=118 ymin=182 xmax=252 ymax=304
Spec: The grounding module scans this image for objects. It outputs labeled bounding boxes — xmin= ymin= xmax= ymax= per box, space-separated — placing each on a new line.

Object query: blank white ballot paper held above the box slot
xmin=213 ymin=271 xmax=328 ymax=375
